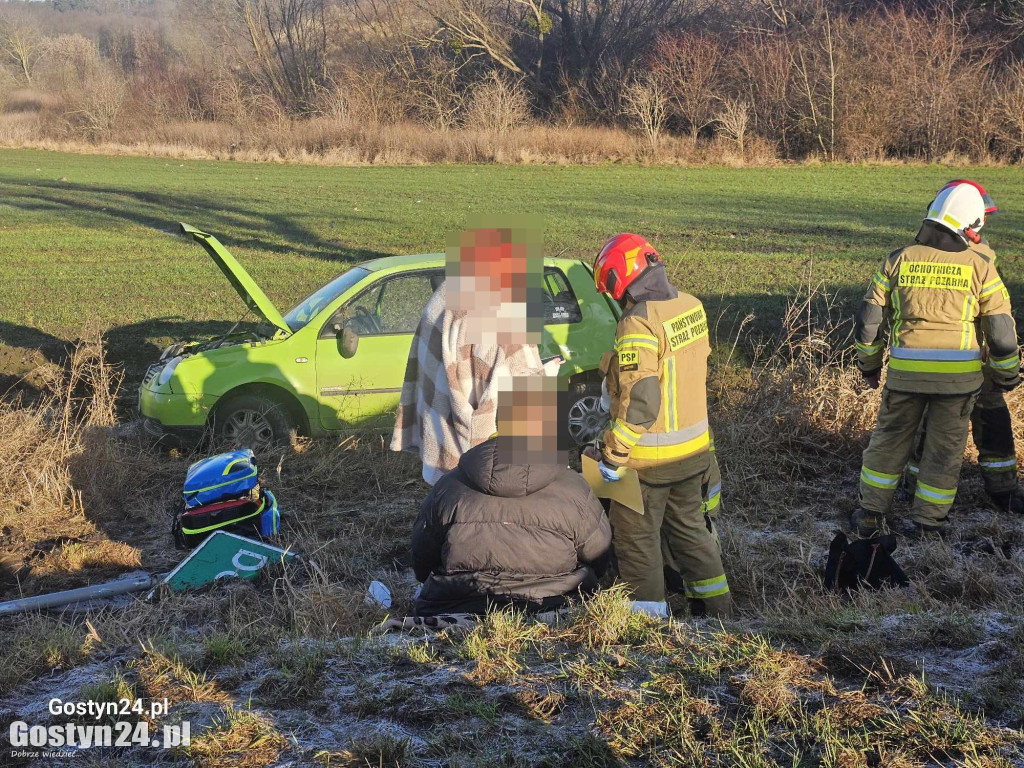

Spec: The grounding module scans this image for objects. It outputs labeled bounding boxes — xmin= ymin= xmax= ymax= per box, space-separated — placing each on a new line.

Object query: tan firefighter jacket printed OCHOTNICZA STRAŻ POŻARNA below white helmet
xmin=854 ymin=222 xmax=1020 ymax=394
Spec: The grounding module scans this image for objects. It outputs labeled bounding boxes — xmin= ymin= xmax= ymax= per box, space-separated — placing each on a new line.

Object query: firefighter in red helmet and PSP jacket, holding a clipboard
xmin=594 ymin=233 xmax=732 ymax=616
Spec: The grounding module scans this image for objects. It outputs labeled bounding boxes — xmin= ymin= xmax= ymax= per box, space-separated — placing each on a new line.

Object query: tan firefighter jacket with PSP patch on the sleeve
xmin=602 ymin=280 xmax=711 ymax=484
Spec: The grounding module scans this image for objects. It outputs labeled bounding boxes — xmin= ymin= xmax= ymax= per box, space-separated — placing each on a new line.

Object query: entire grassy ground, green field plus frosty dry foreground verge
xmin=0 ymin=151 xmax=1024 ymax=768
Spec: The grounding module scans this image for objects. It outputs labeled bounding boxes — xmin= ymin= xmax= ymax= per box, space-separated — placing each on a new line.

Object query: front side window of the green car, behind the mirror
xmin=324 ymin=269 xmax=444 ymax=336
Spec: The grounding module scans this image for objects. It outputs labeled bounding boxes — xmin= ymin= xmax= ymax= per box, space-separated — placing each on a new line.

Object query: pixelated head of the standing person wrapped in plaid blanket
xmin=445 ymin=226 xmax=544 ymax=346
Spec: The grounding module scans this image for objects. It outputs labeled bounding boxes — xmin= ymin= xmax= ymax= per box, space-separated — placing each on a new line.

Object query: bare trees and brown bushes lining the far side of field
xmin=0 ymin=0 xmax=1024 ymax=162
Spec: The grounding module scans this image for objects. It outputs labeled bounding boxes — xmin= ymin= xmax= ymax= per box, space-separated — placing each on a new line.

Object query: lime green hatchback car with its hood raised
xmin=139 ymin=224 xmax=618 ymax=445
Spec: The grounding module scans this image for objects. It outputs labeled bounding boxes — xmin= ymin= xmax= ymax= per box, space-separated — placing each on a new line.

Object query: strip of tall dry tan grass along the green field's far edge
xmin=0 ymin=112 xmax=777 ymax=166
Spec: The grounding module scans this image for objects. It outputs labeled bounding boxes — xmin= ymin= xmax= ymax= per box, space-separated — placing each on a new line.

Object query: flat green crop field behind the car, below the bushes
xmin=0 ymin=150 xmax=1024 ymax=376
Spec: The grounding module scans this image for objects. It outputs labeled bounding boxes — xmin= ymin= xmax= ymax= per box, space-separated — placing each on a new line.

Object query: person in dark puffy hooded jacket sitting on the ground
xmin=413 ymin=377 xmax=611 ymax=615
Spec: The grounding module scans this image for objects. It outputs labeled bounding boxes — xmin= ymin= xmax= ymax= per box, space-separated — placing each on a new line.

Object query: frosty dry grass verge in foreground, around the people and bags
xmin=0 ymin=281 xmax=1024 ymax=768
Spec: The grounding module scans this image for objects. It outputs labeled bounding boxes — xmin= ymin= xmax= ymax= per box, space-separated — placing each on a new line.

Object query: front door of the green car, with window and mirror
xmin=316 ymin=269 xmax=444 ymax=429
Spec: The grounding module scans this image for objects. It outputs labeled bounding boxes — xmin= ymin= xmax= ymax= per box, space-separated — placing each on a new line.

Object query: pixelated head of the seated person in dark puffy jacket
xmin=498 ymin=376 xmax=568 ymax=467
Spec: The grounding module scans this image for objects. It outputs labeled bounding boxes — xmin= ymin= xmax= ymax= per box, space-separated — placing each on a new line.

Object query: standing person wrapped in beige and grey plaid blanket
xmin=391 ymin=228 xmax=544 ymax=485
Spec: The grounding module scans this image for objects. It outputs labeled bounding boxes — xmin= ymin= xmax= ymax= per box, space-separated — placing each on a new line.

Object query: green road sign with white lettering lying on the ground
xmin=150 ymin=530 xmax=296 ymax=595
